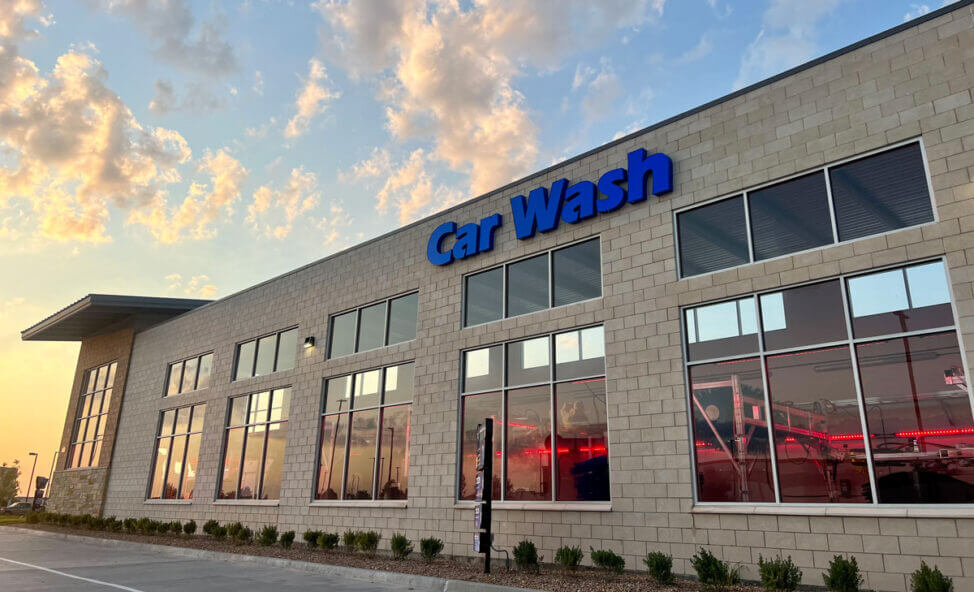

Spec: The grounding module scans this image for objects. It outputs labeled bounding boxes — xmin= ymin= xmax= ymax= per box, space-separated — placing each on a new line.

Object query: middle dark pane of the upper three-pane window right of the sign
xmin=747 ymin=172 xmax=833 ymax=261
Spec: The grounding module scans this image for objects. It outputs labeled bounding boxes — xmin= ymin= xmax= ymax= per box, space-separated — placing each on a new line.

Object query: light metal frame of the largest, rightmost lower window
xmin=679 ymin=256 xmax=974 ymax=510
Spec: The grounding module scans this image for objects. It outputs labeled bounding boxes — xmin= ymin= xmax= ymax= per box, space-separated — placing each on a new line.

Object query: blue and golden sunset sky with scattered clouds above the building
xmin=0 ymin=0 xmax=960 ymax=494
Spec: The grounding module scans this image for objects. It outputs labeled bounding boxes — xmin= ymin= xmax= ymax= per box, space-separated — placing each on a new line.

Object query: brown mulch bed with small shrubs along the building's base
xmin=11 ymin=524 xmax=761 ymax=592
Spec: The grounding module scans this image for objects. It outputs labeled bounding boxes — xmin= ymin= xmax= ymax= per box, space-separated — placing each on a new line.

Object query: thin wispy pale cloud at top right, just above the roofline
xmin=734 ymin=0 xmax=841 ymax=90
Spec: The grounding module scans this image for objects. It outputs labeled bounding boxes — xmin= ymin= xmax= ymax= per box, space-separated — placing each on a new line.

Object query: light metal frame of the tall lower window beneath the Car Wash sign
xmin=453 ymin=326 xmax=612 ymax=510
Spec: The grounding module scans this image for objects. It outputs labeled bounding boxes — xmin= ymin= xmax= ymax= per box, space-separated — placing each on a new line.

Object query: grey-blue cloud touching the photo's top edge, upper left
xmin=89 ymin=0 xmax=237 ymax=76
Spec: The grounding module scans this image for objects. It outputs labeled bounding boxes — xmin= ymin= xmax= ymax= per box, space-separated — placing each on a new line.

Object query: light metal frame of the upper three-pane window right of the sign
xmin=671 ymin=136 xmax=940 ymax=281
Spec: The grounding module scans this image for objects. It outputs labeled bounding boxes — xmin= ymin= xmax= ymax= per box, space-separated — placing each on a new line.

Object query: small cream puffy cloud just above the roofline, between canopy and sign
xmin=247 ymin=167 xmax=321 ymax=240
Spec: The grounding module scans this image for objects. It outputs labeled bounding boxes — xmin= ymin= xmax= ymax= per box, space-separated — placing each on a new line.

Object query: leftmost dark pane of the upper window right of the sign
xmin=676 ymin=196 xmax=748 ymax=277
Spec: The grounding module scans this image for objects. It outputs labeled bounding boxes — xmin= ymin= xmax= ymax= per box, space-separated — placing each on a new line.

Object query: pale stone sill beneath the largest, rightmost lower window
xmin=690 ymin=504 xmax=974 ymax=518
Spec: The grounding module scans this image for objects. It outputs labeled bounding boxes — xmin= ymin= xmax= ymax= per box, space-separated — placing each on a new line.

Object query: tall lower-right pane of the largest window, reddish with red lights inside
xmin=856 ymin=332 xmax=974 ymax=504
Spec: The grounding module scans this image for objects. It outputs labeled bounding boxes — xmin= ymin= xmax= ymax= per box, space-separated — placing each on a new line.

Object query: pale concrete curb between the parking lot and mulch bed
xmin=7 ymin=528 xmax=537 ymax=592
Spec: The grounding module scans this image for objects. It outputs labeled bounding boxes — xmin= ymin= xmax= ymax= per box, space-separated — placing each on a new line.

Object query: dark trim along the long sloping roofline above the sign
xmin=141 ymin=0 xmax=974 ymax=324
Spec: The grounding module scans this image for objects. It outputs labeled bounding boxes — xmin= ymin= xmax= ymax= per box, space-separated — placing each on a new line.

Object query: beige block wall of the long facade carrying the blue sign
xmin=93 ymin=7 xmax=974 ymax=591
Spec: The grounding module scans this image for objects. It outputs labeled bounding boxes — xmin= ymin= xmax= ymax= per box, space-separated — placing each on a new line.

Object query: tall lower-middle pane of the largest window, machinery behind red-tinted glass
xmin=767 ymin=346 xmax=873 ymax=503
